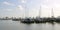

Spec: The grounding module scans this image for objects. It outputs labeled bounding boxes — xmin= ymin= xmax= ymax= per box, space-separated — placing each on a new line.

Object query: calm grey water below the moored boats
xmin=0 ymin=20 xmax=60 ymax=30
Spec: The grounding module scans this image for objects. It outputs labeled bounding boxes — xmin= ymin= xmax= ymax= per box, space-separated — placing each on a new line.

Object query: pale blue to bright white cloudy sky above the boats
xmin=0 ymin=0 xmax=60 ymax=17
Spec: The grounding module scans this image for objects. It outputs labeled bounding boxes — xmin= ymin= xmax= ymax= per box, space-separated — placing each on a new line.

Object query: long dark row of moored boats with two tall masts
xmin=12 ymin=7 xmax=60 ymax=23
